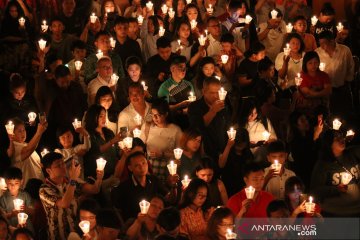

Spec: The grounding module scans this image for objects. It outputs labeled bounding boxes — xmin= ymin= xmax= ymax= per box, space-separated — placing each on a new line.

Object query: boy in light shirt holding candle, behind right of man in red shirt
xmin=263 ymin=140 xmax=295 ymax=199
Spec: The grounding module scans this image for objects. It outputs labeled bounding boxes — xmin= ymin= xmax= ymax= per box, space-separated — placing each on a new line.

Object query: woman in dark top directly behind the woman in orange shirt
xmin=195 ymin=157 xmax=228 ymax=207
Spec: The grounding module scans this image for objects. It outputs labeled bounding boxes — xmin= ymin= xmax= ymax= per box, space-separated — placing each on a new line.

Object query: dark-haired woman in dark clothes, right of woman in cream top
xmin=178 ymin=128 xmax=202 ymax=177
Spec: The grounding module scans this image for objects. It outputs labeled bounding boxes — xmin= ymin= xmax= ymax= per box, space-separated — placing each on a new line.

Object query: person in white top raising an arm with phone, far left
xmin=8 ymin=118 xmax=48 ymax=185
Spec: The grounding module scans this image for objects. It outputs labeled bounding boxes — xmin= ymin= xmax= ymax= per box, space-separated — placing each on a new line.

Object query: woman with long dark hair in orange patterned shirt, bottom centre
xmin=180 ymin=179 xmax=211 ymax=240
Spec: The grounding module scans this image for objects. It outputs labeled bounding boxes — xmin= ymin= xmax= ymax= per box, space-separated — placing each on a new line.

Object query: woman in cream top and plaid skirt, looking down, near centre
xmin=140 ymin=99 xmax=182 ymax=181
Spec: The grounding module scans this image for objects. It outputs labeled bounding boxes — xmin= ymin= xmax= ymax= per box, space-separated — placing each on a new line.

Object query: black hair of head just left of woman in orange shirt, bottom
xmin=156 ymin=207 xmax=181 ymax=232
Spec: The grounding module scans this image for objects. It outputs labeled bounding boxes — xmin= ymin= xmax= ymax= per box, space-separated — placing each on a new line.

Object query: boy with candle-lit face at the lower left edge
xmin=0 ymin=167 xmax=34 ymax=231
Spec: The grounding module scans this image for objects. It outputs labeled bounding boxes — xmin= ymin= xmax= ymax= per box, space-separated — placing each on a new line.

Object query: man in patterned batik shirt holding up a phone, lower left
xmin=39 ymin=152 xmax=104 ymax=240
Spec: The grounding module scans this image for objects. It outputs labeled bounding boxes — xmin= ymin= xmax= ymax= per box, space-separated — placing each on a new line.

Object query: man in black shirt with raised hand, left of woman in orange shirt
xmin=111 ymin=152 xmax=178 ymax=220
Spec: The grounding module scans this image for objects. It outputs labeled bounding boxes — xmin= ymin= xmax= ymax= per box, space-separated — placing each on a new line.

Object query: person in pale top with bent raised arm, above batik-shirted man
xmin=55 ymin=127 xmax=91 ymax=178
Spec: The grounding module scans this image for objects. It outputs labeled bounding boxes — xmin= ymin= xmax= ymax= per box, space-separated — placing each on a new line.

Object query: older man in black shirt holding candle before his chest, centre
xmin=188 ymin=78 xmax=230 ymax=162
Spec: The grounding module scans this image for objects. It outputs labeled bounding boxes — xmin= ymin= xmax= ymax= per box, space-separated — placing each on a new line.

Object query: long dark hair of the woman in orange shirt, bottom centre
xmin=180 ymin=178 xmax=209 ymax=210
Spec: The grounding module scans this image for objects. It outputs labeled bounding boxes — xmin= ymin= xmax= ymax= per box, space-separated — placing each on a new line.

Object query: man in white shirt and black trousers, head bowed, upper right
xmin=315 ymin=31 xmax=354 ymax=116
